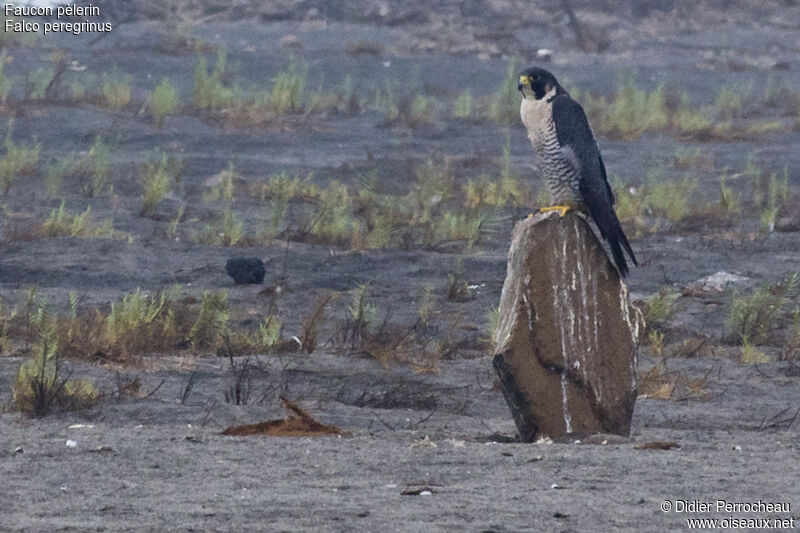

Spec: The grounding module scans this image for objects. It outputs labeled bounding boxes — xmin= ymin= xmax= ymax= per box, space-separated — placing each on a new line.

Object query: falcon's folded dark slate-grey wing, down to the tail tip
xmin=553 ymin=94 xmax=638 ymax=277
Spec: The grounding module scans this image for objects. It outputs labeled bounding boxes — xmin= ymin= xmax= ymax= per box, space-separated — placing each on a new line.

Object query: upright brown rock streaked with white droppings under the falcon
xmin=494 ymin=213 xmax=644 ymax=442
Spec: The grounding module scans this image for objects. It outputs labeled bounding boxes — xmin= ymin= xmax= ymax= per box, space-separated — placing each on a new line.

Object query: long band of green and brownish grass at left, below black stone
xmin=0 ymin=287 xmax=298 ymax=364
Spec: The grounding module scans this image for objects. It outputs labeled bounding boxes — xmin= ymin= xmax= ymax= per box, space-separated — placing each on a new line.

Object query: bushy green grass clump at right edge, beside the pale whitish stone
xmin=728 ymin=272 xmax=798 ymax=344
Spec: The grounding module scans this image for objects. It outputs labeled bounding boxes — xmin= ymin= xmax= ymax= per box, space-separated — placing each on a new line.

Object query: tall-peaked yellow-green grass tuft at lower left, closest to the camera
xmin=11 ymin=304 xmax=100 ymax=418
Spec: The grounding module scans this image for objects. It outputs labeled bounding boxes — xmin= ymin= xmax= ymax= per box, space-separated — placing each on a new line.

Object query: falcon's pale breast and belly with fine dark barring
xmin=520 ymin=98 xmax=583 ymax=206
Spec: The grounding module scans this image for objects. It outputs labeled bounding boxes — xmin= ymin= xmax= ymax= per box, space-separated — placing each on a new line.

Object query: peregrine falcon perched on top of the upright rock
xmin=517 ymin=67 xmax=638 ymax=277
